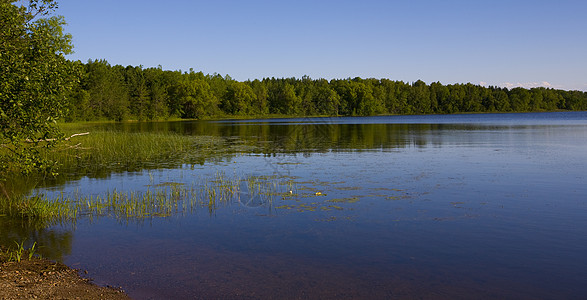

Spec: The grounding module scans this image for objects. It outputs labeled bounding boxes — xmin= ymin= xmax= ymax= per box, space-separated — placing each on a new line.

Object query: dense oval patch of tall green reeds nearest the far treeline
xmin=44 ymin=130 xmax=229 ymax=173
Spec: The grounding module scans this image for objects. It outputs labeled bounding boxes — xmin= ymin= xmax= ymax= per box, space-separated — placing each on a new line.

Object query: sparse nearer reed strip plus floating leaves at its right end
xmin=0 ymin=164 xmax=385 ymax=227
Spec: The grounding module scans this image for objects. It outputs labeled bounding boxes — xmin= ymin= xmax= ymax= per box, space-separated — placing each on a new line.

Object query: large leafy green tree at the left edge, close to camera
xmin=0 ymin=0 xmax=79 ymax=180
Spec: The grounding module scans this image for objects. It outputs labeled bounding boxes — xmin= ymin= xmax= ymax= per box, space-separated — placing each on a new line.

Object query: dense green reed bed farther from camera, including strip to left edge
xmin=0 ymin=129 xmax=230 ymax=197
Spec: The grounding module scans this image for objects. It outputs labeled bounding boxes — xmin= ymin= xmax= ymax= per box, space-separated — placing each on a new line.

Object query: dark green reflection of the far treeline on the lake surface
xmin=87 ymin=116 xmax=576 ymax=157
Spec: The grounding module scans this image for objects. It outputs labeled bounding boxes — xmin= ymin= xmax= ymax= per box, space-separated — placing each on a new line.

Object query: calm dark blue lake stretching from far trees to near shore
xmin=6 ymin=112 xmax=587 ymax=299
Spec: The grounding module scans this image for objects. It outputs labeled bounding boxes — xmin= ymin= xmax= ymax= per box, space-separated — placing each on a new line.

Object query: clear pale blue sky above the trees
xmin=57 ymin=0 xmax=587 ymax=91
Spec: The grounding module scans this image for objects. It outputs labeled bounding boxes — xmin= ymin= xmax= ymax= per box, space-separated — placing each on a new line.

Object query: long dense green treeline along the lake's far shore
xmin=66 ymin=60 xmax=587 ymax=121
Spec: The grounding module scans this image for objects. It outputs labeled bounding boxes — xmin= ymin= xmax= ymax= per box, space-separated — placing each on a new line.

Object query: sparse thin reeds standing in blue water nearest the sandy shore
xmin=0 ymin=173 xmax=295 ymax=227
